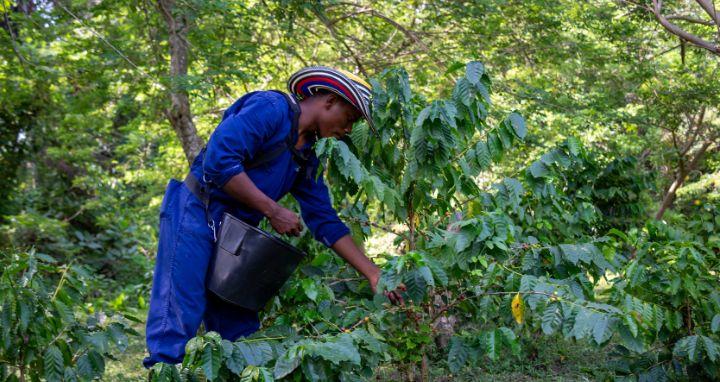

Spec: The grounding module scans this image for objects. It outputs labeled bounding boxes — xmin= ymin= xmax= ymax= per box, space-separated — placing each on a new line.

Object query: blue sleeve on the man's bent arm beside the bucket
xmin=203 ymin=92 xmax=288 ymax=188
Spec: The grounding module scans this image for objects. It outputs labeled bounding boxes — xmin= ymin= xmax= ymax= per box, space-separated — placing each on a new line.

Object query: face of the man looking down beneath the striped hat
xmin=318 ymin=94 xmax=362 ymax=139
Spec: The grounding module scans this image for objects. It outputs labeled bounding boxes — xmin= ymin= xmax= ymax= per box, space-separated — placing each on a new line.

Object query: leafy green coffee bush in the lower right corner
xmin=609 ymin=222 xmax=720 ymax=378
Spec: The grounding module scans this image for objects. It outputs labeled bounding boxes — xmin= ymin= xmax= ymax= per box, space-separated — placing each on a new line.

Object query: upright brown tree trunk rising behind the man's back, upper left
xmin=158 ymin=0 xmax=204 ymax=163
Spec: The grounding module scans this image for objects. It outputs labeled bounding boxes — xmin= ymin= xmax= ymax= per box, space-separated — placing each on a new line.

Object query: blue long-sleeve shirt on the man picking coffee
xmin=190 ymin=91 xmax=350 ymax=247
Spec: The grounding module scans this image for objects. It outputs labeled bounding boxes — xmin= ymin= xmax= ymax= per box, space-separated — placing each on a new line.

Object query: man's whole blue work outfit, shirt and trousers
xmin=143 ymin=91 xmax=350 ymax=367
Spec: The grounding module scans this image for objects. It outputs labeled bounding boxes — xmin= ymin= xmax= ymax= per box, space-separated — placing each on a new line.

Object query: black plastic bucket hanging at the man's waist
xmin=207 ymin=213 xmax=305 ymax=312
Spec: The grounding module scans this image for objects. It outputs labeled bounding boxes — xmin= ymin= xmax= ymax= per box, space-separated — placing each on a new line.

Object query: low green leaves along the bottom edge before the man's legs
xmin=152 ymin=327 xmax=385 ymax=381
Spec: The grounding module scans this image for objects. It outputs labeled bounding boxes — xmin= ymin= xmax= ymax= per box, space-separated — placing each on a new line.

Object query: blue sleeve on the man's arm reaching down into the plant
xmin=290 ymin=163 xmax=350 ymax=247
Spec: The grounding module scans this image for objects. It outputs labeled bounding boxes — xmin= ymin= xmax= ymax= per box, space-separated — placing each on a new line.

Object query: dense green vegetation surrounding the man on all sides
xmin=0 ymin=0 xmax=720 ymax=381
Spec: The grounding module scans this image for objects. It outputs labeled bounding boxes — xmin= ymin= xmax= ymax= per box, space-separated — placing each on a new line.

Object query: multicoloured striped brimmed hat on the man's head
xmin=288 ymin=66 xmax=376 ymax=131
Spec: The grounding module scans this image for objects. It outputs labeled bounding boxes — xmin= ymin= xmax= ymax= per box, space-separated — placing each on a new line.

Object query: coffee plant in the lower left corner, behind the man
xmin=0 ymin=251 xmax=137 ymax=381
